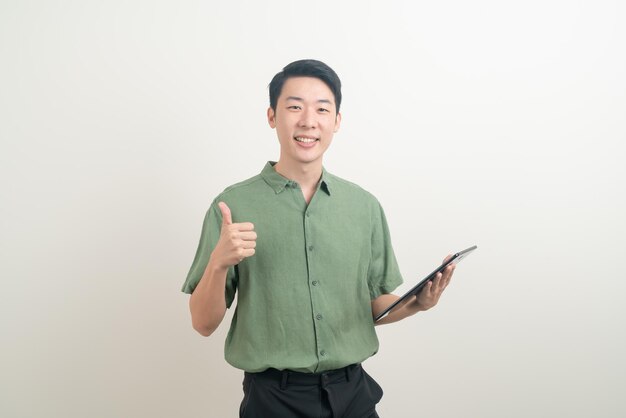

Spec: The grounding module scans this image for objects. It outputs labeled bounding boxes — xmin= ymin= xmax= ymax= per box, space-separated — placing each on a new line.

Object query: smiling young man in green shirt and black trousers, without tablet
xmin=183 ymin=60 xmax=454 ymax=418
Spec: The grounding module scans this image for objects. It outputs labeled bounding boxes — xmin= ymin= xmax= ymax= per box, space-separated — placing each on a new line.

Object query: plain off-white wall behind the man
xmin=0 ymin=0 xmax=626 ymax=418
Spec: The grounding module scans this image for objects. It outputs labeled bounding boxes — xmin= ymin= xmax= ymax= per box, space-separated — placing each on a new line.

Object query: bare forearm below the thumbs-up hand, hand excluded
xmin=189 ymin=260 xmax=228 ymax=337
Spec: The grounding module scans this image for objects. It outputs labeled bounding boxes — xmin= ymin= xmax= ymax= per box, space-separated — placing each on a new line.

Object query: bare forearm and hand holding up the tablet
xmin=372 ymin=256 xmax=455 ymax=325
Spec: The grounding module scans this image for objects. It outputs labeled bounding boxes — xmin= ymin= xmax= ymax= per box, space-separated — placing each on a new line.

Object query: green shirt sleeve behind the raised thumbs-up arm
xmin=182 ymin=201 xmax=237 ymax=308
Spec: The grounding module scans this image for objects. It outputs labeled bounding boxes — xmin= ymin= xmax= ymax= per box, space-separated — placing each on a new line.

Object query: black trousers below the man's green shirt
xmin=239 ymin=364 xmax=383 ymax=418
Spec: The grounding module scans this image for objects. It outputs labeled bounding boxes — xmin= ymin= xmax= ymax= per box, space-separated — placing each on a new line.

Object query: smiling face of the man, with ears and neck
xmin=267 ymin=77 xmax=341 ymax=166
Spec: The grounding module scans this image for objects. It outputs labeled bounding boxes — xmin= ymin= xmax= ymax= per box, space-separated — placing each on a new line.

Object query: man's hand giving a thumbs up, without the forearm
xmin=211 ymin=202 xmax=256 ymax=269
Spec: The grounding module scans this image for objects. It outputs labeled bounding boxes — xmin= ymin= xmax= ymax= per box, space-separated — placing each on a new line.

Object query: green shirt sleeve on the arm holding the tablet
xmin=367 ymin=201 xmax=402 ymax=300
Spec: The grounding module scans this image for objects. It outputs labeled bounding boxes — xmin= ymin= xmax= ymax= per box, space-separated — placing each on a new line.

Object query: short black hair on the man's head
xmin=269 ymin=59 xmax=341 ymax=113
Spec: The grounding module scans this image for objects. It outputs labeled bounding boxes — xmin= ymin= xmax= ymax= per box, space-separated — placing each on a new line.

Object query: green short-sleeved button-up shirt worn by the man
xmin=182 ymin=162 xmax=402 ymax=372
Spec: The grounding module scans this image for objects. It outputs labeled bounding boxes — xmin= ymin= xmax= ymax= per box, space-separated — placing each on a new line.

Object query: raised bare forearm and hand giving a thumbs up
xmin=189 ymin=202 xmax=256 ymax=337
